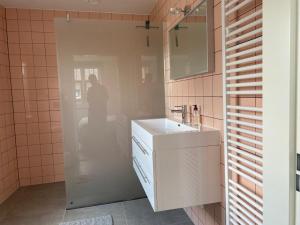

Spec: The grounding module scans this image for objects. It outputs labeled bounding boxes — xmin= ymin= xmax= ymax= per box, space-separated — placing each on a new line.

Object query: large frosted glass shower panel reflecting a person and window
xmin=55 ymin=19 xmax=165 ymax=208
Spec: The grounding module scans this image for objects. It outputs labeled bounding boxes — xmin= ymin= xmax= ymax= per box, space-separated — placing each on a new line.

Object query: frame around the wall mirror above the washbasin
xmin=168 ymin=0 xmax=215 ymax=80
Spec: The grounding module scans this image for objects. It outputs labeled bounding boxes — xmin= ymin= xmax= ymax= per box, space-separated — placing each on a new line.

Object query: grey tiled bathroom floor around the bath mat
xmin=0 ymin=183 xmax=193 ymax=225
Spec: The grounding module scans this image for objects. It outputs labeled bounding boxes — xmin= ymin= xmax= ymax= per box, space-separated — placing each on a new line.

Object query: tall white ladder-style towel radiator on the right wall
xmin=222 ymin=0 xmax=263 ymax=225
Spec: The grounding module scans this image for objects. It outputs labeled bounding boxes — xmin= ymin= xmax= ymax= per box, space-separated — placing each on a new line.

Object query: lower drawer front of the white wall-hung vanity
xmin=132 ymin=156 xmax=155 ymax=207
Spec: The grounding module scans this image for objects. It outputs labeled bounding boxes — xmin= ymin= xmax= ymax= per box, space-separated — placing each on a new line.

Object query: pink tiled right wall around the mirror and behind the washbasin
xmin=151 ymin=0 xmax=225 ymax=225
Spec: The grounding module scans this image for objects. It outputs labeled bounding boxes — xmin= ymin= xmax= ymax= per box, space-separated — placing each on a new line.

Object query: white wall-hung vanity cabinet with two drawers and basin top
xmin=132 ymin=119 xmax=221 ymax=211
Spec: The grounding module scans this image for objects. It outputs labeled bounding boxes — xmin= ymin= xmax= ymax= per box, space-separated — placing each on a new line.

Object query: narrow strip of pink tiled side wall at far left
xmin=0 ymin=6 xmax=19 ymax=203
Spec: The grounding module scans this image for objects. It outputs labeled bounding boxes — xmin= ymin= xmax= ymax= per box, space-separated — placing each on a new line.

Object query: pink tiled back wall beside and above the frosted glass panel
xmin=6 ymin=9 xmax=148 ymax=186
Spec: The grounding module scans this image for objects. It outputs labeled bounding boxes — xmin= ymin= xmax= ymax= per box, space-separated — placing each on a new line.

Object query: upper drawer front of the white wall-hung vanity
xmin=132 ymin=137 xmax=153 ymax=180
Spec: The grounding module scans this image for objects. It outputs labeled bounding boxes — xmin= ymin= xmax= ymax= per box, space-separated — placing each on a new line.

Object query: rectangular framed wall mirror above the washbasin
xmin=169 ymin=0 xmax=214 ymax=80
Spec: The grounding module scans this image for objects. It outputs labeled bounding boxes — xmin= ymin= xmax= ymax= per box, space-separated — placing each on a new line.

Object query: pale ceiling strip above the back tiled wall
xmin=0 ymin=0 xmax=157 ymax=14
